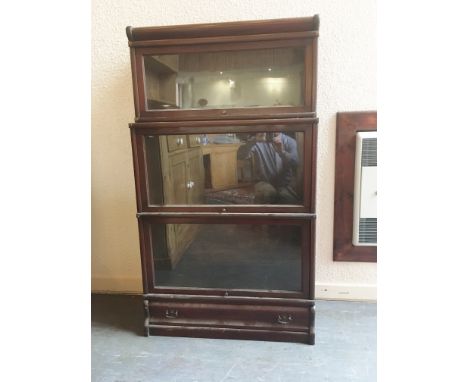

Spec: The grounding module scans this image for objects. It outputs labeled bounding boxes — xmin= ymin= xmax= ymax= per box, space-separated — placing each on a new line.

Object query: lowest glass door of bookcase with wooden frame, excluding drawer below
xmin=140 ymin=216 xmax=313 ymax=292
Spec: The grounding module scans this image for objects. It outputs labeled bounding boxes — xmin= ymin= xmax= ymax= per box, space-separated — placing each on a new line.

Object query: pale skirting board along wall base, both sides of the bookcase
xmin=91 ymin=277 xmax=377 ymax=301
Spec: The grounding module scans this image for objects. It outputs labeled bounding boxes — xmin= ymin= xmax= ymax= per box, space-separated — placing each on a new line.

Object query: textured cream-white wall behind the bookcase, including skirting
xmin=92 ymin=0 xmax=377 ymax=299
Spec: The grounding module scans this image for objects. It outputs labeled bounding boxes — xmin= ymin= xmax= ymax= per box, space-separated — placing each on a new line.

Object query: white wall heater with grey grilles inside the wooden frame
xmin=353 ymin=131 xmax=377 ymax=246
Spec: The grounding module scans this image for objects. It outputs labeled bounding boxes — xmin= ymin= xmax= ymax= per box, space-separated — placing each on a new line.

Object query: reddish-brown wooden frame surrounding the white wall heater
xmin=333 ymin=111 xmax=377 ymax=262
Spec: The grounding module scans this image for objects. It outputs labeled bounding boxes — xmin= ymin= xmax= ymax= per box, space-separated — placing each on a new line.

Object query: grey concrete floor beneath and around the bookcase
xmin=91 ymin=294 xmax=377 ymax=382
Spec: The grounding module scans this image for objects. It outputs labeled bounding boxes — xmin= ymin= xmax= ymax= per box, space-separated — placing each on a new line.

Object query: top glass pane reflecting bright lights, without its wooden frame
xmin=144 ymin=48 xmax=304 ymax=109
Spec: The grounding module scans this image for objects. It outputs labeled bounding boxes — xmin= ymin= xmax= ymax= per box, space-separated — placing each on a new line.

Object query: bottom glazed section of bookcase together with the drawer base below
xmin=141 ymin=217 xmax=315 ymax=344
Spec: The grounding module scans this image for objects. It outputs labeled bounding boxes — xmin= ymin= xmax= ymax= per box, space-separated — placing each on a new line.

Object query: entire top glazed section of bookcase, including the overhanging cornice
xmin=127 ymin=17 xmax=318 ymax=122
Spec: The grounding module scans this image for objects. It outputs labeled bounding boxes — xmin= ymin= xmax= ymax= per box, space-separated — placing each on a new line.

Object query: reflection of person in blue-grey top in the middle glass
xmin=238 ymin=133 xmax=299 ymax=204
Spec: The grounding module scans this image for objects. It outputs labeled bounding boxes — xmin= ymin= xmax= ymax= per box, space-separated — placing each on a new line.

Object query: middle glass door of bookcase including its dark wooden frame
xmin=135 ymin=118 xmax=315 ymax=212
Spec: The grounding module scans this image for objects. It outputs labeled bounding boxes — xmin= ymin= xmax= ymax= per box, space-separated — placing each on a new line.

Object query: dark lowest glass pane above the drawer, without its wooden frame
xmin=151 ymin=224 xmax=301 ymax=291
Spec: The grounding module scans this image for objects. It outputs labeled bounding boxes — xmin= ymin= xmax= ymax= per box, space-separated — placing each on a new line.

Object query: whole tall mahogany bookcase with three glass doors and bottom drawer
xmin=127 ymin=15 xmax=319 ymax=344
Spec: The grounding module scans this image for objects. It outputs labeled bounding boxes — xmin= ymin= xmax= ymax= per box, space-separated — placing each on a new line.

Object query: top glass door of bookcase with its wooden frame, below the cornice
xmin=130 ymin=39 xmax=316 ymax=122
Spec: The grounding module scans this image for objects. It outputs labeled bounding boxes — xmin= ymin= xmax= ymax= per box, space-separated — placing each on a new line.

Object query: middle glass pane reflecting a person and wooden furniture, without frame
xmin=144 ymin=132 xmax=304 ymax=205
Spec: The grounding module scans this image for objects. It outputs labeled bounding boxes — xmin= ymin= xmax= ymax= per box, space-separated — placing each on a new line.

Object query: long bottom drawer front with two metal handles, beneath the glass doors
xmin=149 ymin=302 xmax=310 ymax=332
